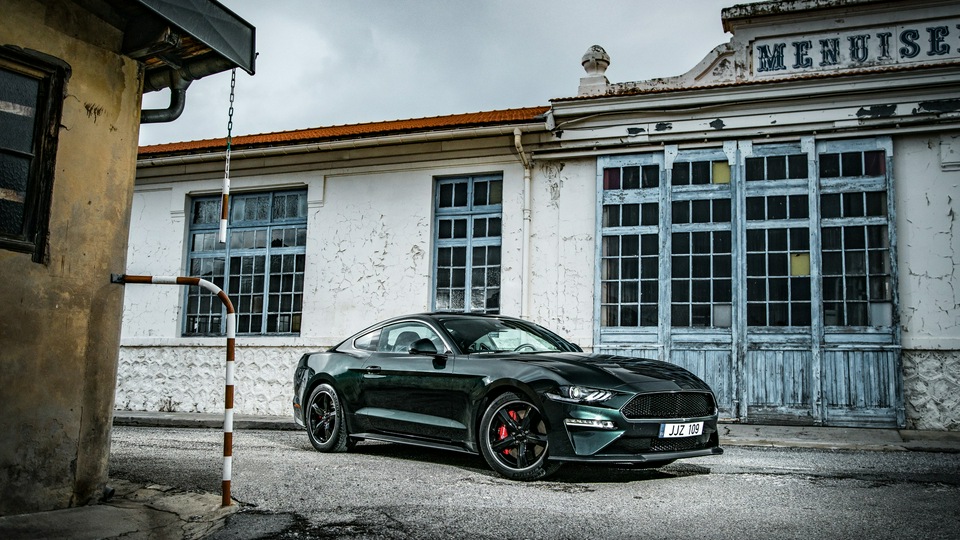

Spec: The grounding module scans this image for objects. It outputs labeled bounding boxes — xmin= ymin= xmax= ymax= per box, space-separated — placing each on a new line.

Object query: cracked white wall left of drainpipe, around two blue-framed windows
xmin=116 ymin=159 xmax=532 ymax=415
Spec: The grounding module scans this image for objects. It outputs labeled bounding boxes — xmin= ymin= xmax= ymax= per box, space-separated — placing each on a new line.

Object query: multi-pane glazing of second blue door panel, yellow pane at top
xmin=670 ymin=151 xmax=733 ymax=327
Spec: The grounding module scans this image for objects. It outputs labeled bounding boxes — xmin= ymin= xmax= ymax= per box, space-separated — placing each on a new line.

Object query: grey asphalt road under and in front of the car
xmin=110 ymin=427 xmax=960 ymax=540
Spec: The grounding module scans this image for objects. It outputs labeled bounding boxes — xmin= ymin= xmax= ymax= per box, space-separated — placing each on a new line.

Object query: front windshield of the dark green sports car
xmin=440 ymin=317 xmax=579 ymax=353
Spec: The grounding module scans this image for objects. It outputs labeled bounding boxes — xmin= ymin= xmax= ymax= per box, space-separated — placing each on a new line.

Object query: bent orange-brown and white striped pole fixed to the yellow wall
xmin=110 ymin=275 xmax=237 ymax=506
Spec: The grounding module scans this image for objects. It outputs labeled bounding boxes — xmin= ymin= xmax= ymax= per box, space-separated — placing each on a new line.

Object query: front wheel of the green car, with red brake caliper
xmin=480 ymin=393 xmax=560 ymax=481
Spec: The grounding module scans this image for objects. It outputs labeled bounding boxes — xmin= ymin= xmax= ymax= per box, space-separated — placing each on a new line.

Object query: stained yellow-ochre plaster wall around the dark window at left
xmin=0 ymin=0 xmax=140 ymax=514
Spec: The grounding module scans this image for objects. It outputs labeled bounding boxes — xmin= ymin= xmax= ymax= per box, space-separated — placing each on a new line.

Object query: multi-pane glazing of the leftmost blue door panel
xmin=600 ymin=158 xmax=660 ymax=327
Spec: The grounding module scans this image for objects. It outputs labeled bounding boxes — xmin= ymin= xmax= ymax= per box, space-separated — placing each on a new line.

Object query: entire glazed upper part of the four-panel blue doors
xmin=597 ymin=138 xmax=895 ymax=336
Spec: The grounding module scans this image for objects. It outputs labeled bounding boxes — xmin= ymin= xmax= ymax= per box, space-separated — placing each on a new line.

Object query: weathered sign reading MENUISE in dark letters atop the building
xmin=752 ymin=19 xmax=960 ymax=77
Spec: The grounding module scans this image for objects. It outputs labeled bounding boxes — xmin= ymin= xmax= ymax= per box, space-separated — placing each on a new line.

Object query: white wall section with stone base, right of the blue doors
xmin=894 ymin=134 xmax=960 ymax=430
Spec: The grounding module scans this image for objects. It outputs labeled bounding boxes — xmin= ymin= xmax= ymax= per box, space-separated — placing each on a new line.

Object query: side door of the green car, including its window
xmin=356 ymin=321 xmax=467 ymax=441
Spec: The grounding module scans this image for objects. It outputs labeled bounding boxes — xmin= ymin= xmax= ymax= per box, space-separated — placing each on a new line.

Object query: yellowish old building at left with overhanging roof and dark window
xmin=0 ymin=0 xmax=256 ymax=515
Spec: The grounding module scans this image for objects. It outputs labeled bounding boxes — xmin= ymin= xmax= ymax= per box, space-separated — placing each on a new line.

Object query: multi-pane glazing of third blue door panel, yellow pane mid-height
xmin=744 ymin=145 xmax=812 ymax=326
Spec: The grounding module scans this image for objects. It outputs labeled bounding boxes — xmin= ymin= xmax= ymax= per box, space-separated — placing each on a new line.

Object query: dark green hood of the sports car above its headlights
xmin=514 ymin=353 xmax=710 ymax=392
